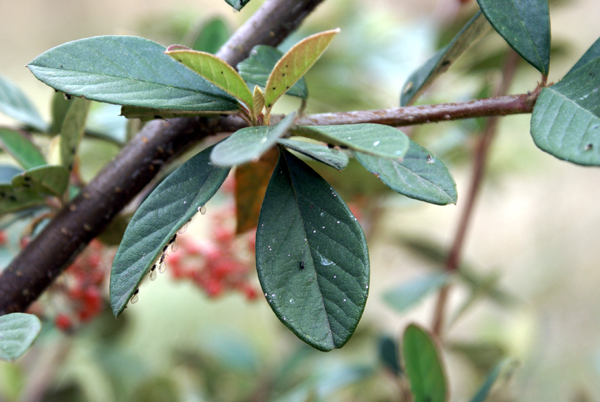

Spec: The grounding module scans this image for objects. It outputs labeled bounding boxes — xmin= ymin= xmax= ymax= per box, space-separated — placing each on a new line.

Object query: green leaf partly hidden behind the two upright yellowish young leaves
xmin=237 ymin=45 xmax=308 ymax=99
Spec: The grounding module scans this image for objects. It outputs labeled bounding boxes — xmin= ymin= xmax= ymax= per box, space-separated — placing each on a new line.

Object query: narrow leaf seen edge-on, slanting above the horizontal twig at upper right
xmin=400 ymin=12 xmax=491 ymax=106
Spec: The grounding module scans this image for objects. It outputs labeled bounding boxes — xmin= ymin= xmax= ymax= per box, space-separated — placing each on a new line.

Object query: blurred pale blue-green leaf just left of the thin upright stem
xmin=383 ymin=272 xmax=450 ymax=313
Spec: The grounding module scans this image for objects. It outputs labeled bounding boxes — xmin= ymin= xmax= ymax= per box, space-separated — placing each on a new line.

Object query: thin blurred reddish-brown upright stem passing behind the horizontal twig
xmin=432 ymin=51 xmax=520 ymax=336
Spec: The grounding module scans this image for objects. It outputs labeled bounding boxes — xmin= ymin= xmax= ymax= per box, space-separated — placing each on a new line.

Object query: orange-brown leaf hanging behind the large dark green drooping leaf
xmin=235 ymin=148 xmax=279 ymax=233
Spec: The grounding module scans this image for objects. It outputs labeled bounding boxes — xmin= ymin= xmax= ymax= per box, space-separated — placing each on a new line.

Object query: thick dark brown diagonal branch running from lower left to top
xmin=0 ymin=0 xmax=323 ymax=315
